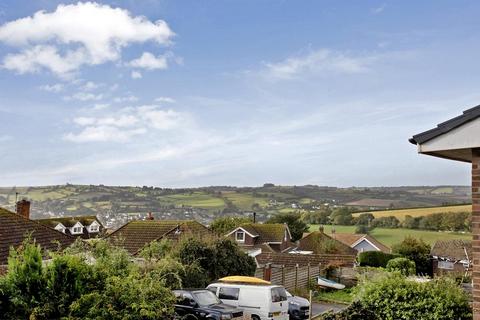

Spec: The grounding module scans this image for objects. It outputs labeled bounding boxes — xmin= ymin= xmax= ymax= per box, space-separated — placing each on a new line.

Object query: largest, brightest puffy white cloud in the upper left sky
xmin=0 ymin=2 xmax=174 ymax=77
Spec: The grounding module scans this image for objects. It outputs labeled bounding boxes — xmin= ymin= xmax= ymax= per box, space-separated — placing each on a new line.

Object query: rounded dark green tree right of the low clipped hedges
xmin=392 ymin=236 xmax=432 ymax=274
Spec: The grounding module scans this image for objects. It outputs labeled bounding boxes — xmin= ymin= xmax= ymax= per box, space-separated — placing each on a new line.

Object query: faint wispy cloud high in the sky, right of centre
xmin=261 ymin=49 xmax=374 ymax=80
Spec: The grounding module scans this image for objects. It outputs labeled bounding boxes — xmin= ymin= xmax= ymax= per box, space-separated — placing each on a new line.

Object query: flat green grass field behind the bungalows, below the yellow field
xmin=310 ymin=225 xmax=472 ymax=247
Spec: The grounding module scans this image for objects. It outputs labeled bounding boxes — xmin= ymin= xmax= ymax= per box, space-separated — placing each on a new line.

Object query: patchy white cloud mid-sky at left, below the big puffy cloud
xmin=64 ymin=105 xmax=187 ymax=143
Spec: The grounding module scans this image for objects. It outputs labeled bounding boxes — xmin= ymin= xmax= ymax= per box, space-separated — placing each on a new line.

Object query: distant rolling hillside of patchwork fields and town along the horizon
xmin=0 ymin=183 xmax=471 ymax=228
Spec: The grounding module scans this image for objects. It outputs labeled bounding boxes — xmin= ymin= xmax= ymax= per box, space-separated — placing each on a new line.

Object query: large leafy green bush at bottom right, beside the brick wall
xmin=322 ymin=273 xmax=472 ymax=320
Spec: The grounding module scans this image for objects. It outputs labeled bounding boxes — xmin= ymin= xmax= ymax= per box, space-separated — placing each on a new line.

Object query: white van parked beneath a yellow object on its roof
xmin=207 ymin=283 xmax=288 ymax=320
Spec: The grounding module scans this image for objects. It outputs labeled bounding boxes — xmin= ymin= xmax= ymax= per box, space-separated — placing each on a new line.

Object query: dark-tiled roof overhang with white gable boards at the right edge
xmin=409 ymin=106 xmax=480 ymax=162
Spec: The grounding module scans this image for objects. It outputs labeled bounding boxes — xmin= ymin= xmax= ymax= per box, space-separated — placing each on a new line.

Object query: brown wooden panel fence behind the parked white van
xmin=255 ymin=264 xmax=322 ymax=291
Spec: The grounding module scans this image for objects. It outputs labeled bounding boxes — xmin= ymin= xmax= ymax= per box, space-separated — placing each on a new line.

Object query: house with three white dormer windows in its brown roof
xmin=37 ymin=216 xmax=105 ymax=239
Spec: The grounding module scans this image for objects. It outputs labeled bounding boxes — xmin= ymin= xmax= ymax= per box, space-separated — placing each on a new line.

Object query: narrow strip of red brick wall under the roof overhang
xmin=472 ymin=149 xmax=480 ymax=320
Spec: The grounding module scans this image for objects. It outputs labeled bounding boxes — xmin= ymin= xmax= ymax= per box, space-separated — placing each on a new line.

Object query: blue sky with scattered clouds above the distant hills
xmin=0 ymin=0 xmax=480 ymax=187
